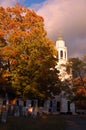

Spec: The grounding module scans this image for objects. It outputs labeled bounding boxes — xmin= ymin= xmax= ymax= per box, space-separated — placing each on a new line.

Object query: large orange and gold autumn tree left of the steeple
xmin=0 ymin=5 xmax=61 ymax=98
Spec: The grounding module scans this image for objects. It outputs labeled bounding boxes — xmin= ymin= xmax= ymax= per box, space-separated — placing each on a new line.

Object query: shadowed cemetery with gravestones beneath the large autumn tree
xmin=0 ymin=97 xmax=73 ymax=123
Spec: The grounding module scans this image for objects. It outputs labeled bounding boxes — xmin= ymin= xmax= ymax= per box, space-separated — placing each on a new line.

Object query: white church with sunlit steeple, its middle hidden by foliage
xmin=36 ymin=37 xmax=75 ymax=114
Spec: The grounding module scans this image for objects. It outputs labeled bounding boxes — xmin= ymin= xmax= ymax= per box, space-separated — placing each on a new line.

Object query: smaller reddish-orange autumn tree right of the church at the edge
xmin=68 ymin=56 xmax=86 ymax=108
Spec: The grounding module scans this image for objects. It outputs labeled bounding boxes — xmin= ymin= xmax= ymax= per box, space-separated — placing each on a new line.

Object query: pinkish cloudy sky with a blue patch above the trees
xmin=0 ymin=0 xmax=86 ymax=57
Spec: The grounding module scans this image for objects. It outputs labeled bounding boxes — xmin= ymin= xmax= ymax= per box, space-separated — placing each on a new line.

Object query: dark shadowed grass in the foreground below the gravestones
xmin=0 ymin=115 xmax=65 ymax=130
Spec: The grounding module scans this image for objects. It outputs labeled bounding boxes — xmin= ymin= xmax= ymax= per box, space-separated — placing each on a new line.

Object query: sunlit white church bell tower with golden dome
xmin=56 ymin=36 xmax=71 ymax=81
